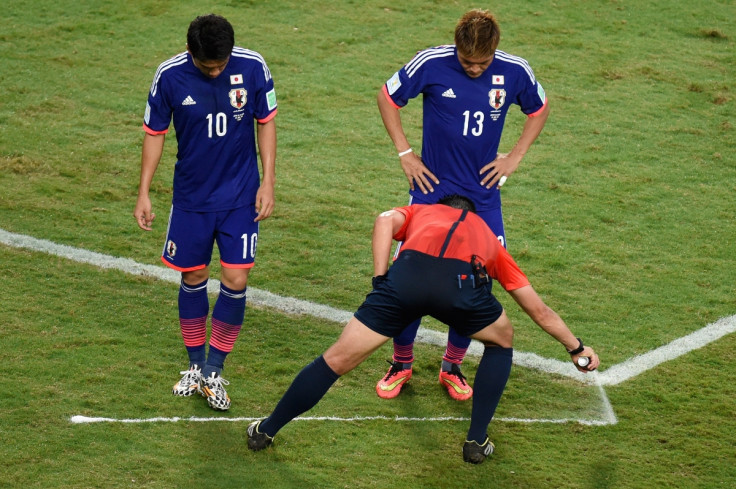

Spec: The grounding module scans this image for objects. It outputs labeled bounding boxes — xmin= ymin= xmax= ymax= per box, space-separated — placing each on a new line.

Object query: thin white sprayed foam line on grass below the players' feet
xmin=70 ymin=415 xmax=615 ymax=426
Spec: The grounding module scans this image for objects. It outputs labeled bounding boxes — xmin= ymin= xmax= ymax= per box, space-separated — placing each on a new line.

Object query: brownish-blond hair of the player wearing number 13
xmin=455 ymin=9 xmax=501 ymax=58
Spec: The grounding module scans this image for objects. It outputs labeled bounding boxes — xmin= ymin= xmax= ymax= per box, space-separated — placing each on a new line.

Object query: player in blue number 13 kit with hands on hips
xmin=376 ymin=9 xmax=549 ymax=400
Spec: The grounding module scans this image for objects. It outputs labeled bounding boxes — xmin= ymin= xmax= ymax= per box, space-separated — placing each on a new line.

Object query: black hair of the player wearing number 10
xmin=187 ymin=14 xmax=235 ymax=61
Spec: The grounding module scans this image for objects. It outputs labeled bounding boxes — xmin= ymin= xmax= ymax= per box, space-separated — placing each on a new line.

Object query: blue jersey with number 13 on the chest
xmin=383 ymin=45 xmax=546 ymax=212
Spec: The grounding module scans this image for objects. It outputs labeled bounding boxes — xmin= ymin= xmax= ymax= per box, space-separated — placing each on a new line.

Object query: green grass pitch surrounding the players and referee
xmin=0 ymin=0 xmax=736 ymax=489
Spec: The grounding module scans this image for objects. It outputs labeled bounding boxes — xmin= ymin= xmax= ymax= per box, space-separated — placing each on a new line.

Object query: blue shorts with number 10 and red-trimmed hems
xmin=161 ymin=206 xmax=259 ymax=272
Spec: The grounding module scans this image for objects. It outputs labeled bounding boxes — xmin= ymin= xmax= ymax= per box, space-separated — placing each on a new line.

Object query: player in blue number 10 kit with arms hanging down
xmin=133 ymin=14 xmax=277 ymax=411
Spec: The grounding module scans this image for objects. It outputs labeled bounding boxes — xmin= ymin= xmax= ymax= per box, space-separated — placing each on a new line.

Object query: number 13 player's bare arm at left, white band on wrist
xmin=377 ymin=90 xmax=440 ymax=194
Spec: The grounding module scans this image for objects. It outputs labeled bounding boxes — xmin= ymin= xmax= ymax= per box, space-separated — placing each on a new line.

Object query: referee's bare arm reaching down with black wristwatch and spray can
xmin=508 ymin=285 xmax=600 ymax=372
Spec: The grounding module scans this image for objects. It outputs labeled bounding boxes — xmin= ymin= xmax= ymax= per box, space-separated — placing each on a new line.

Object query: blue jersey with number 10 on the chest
xmin=143 ymin=47 xmax=277 ymax=212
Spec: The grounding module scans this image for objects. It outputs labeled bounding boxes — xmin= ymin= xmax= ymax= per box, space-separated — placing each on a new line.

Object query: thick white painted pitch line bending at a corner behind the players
xmin=0 ymin=225 xmax=736 ymax=386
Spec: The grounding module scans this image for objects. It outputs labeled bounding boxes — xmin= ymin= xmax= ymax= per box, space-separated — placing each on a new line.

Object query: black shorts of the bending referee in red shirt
xmin=355 ymin=250 xmax=503 ymax=337
